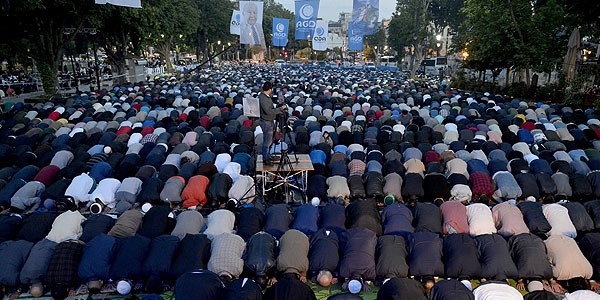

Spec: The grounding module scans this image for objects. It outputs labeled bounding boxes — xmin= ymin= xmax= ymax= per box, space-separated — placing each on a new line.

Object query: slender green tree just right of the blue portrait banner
xmin=388 ymin=0 xmax=431 ymax=76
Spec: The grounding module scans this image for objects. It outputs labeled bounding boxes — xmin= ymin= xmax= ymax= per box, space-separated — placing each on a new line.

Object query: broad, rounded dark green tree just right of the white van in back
xmin=457 ymin=0 xmax=568 ymax=86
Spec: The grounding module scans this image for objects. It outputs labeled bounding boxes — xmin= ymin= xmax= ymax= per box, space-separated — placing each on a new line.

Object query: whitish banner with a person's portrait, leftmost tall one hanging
xmin=240 ymin=1 xmax=265 ymax=48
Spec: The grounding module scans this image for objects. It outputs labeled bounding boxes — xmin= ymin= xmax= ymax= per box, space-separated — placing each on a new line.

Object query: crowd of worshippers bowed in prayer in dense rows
xmin=0 ymin=68 xmax=600 ymax=300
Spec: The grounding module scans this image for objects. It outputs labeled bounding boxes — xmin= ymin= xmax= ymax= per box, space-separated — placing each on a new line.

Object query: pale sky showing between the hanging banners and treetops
xmin=275 ymin=0 xmax=396 ymax=21
